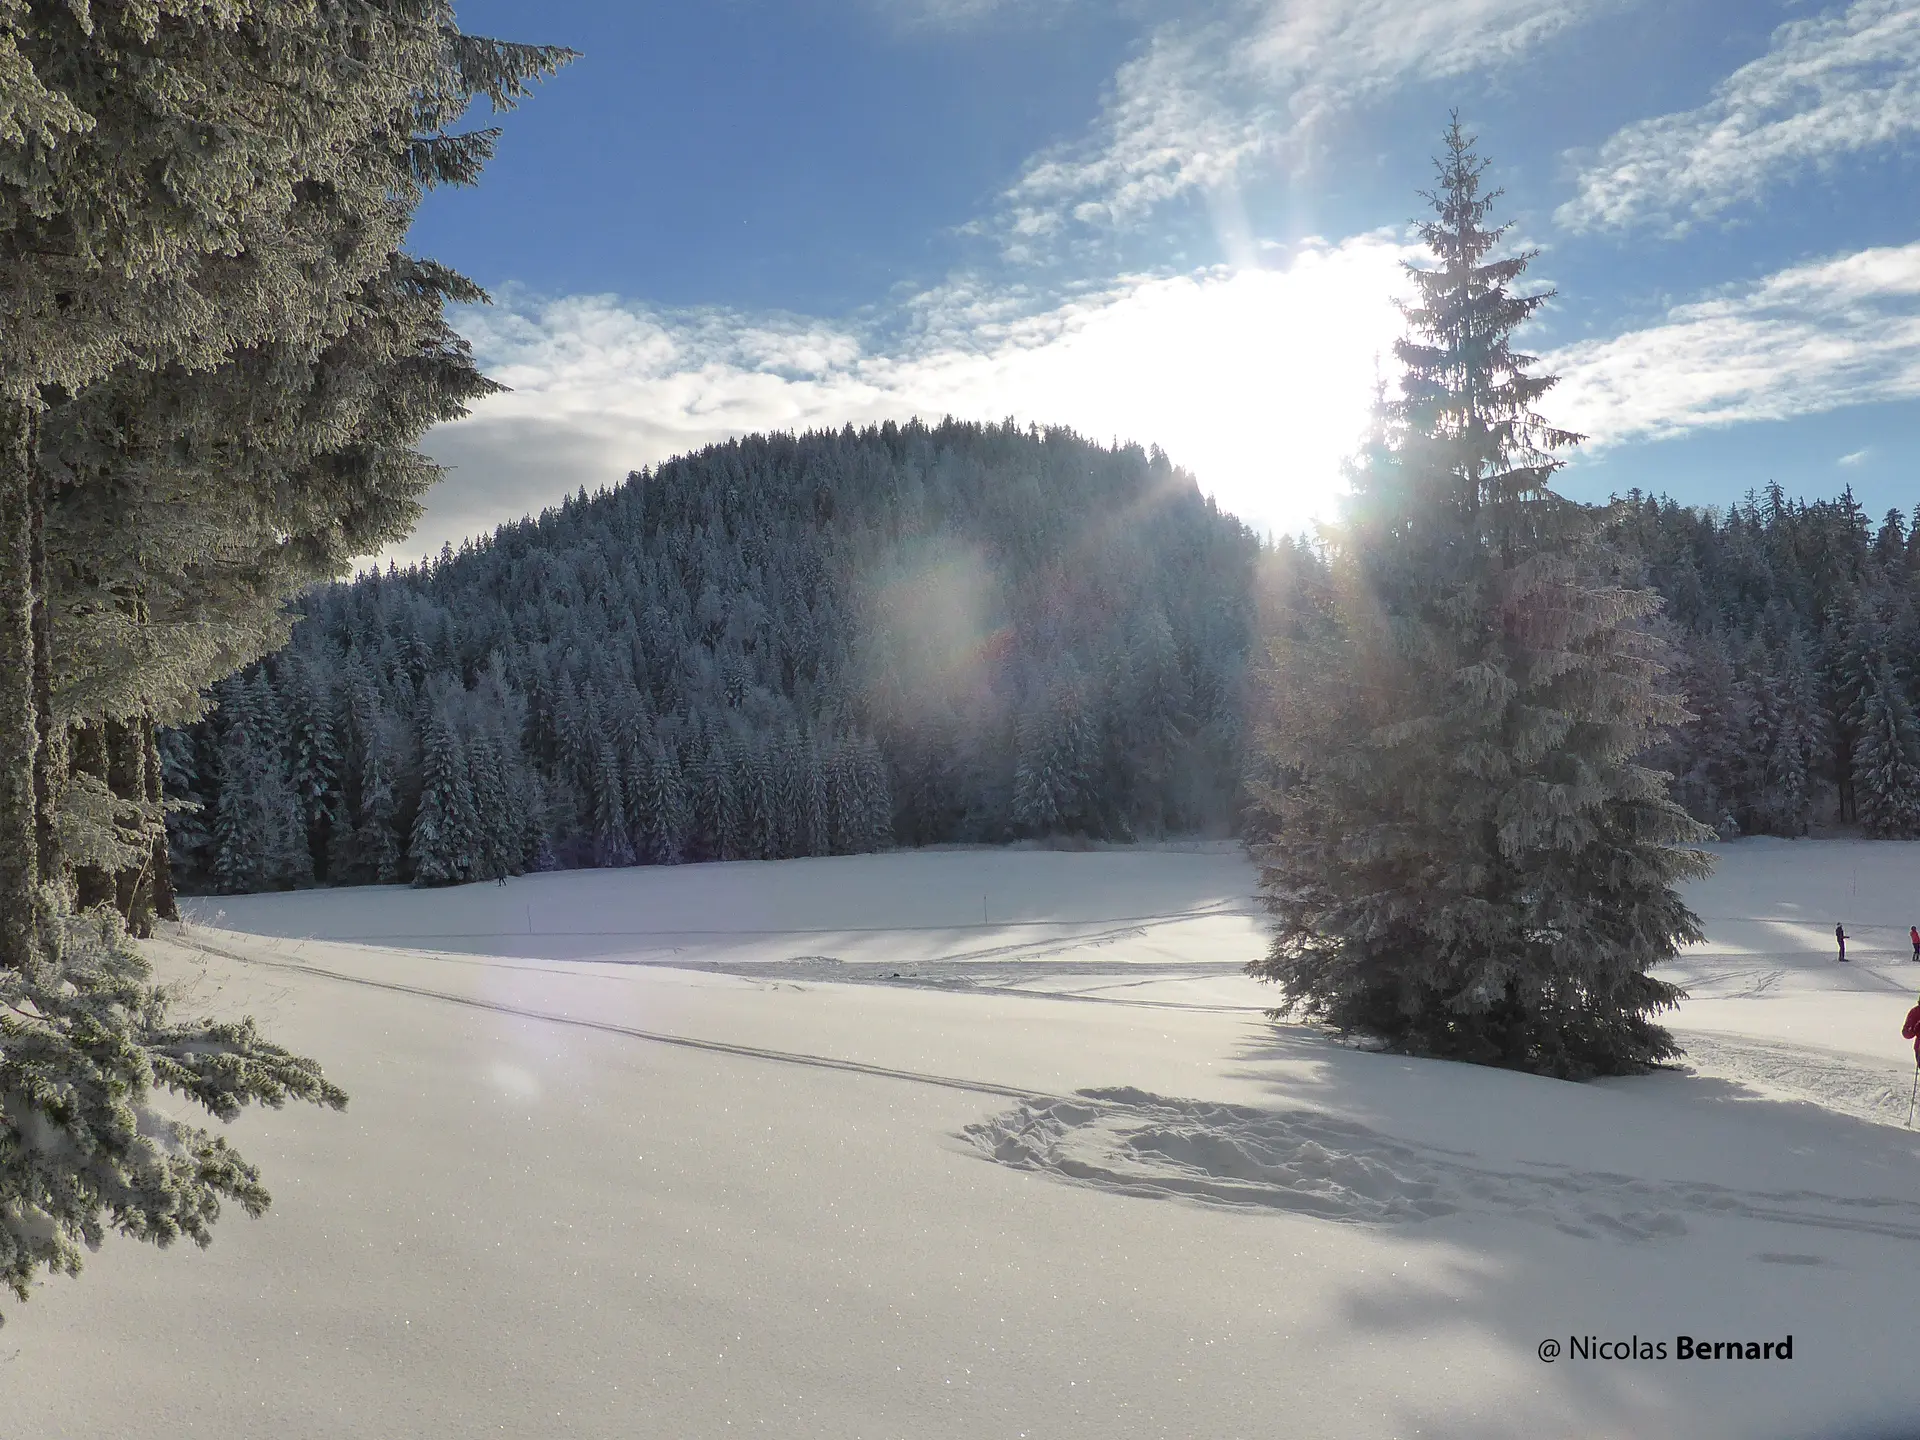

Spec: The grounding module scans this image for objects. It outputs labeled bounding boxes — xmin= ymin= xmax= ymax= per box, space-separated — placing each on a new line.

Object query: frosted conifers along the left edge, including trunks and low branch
xmin=0 ymin=0 xmax=570 ymax=1328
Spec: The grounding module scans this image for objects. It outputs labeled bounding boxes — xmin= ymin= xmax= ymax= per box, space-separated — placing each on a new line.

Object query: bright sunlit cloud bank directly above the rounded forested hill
xmin=399 ymin=232 xmax=1407 ymax=555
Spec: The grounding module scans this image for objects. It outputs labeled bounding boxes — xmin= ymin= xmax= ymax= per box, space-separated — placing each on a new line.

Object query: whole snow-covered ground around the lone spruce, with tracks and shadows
xmin=11 ymin=841 xmax=1920 ymax=1440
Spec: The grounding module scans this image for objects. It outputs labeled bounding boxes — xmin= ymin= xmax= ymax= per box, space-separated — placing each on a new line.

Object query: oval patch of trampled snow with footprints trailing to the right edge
xmin=962 ymin=1087 xmax=1920 ymax=1240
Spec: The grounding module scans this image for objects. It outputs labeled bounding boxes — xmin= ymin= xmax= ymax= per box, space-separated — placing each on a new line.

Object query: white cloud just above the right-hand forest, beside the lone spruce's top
xmin=1546 ymin=242 xmax=1920 ymax=445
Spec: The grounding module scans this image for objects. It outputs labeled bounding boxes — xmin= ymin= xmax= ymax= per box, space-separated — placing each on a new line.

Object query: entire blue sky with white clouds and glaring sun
xmin=403 ymin=0 xmax=1920 ymax=553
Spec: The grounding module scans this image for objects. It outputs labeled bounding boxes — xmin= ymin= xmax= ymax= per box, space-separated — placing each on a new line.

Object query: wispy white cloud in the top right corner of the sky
xmin=1555 ymin=0 xmax=1920 ymax=234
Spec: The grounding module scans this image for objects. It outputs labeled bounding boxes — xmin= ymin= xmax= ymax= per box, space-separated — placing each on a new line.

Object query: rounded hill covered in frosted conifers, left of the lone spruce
xmin=161 ymin=422 xmax=1260 ymax=889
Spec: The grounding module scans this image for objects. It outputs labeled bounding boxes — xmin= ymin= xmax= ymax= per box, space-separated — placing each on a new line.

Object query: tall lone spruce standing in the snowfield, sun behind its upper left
xmin=1250 ymin=117 xmax=1709 ymax=1077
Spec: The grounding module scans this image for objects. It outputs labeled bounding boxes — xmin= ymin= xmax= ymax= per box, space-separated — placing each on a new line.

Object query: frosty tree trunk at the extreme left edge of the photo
xmin=0 ymin=397 xmax=42 ymax=970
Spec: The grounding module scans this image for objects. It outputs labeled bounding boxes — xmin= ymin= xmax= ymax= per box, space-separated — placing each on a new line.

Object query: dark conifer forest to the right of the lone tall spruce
xmin=1617 ymin=484 xmax=1920 ymax=837
